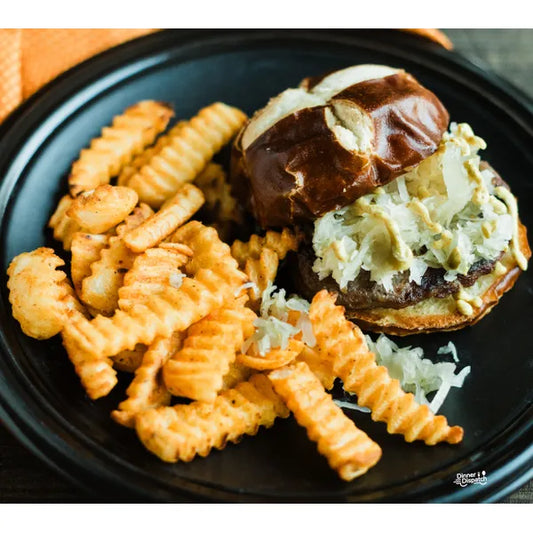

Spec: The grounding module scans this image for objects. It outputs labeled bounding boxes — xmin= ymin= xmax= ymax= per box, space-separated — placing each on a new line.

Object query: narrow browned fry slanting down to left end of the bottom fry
xmin=111 ymin=333 xmax=183 ymax=428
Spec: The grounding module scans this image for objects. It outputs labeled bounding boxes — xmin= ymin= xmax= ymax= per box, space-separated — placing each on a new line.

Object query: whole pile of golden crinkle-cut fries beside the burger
xmin=8 ymin=101 xmax=463 ymax=481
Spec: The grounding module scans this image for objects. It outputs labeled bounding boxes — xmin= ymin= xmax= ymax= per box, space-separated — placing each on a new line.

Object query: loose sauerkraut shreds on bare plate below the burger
xmin=365 ymin=335 xmax=470 ymax=413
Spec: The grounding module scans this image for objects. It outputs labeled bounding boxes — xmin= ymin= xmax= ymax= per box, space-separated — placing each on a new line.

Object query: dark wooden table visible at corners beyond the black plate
xmin=0 ymin=29 xmax=533 ymax=503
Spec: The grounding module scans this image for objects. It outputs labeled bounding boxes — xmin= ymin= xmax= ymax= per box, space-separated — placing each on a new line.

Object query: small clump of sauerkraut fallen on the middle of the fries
xmin=241 ymin=283 xmax=316 ymax=356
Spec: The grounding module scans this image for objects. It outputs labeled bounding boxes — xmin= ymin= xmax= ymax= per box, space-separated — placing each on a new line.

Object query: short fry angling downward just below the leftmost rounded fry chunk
xmin=62 ymin=310 xmax=117 ymax=400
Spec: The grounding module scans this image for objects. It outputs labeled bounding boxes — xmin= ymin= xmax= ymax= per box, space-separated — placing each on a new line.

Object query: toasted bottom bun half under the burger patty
xmin=346 ymin=218 xmax=531 ymax=336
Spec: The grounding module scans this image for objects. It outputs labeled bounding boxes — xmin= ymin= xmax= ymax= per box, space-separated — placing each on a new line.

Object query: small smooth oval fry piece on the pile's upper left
xmin=67 ymin=185 xmax=138 ymax=233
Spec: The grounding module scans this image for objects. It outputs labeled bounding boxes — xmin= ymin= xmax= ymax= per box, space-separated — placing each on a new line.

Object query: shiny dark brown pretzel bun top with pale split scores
xmin=232 ymin=65 xmax=449 ymax=227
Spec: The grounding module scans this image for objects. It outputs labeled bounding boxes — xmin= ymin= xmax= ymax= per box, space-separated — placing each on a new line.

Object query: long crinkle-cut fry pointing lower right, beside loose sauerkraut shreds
xmin=309 ymin=290 xmax=463 ymax=445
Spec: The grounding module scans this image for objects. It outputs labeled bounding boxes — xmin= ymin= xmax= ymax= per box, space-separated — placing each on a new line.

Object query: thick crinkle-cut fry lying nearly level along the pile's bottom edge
xmin=135 ymin=374 xmax=289 ymax=463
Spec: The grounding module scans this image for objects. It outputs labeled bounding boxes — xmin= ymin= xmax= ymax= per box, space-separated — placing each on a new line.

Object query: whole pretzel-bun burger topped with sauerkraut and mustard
xmin=231 ymin=65 xmax=531 ymax=335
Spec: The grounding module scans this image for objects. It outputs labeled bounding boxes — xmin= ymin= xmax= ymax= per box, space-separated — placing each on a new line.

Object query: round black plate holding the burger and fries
xmin=0 ymin=31 xmax=533 ymax=502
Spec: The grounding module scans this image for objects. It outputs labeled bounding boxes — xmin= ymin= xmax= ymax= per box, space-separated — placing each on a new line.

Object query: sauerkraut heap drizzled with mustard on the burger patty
xmin=313 ymin=123 xmax=518 ymax=291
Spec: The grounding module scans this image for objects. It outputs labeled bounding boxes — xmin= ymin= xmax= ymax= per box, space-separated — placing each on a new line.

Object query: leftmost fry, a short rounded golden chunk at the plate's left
xmin=7 ymin=247 xmax=82 ymax=339
